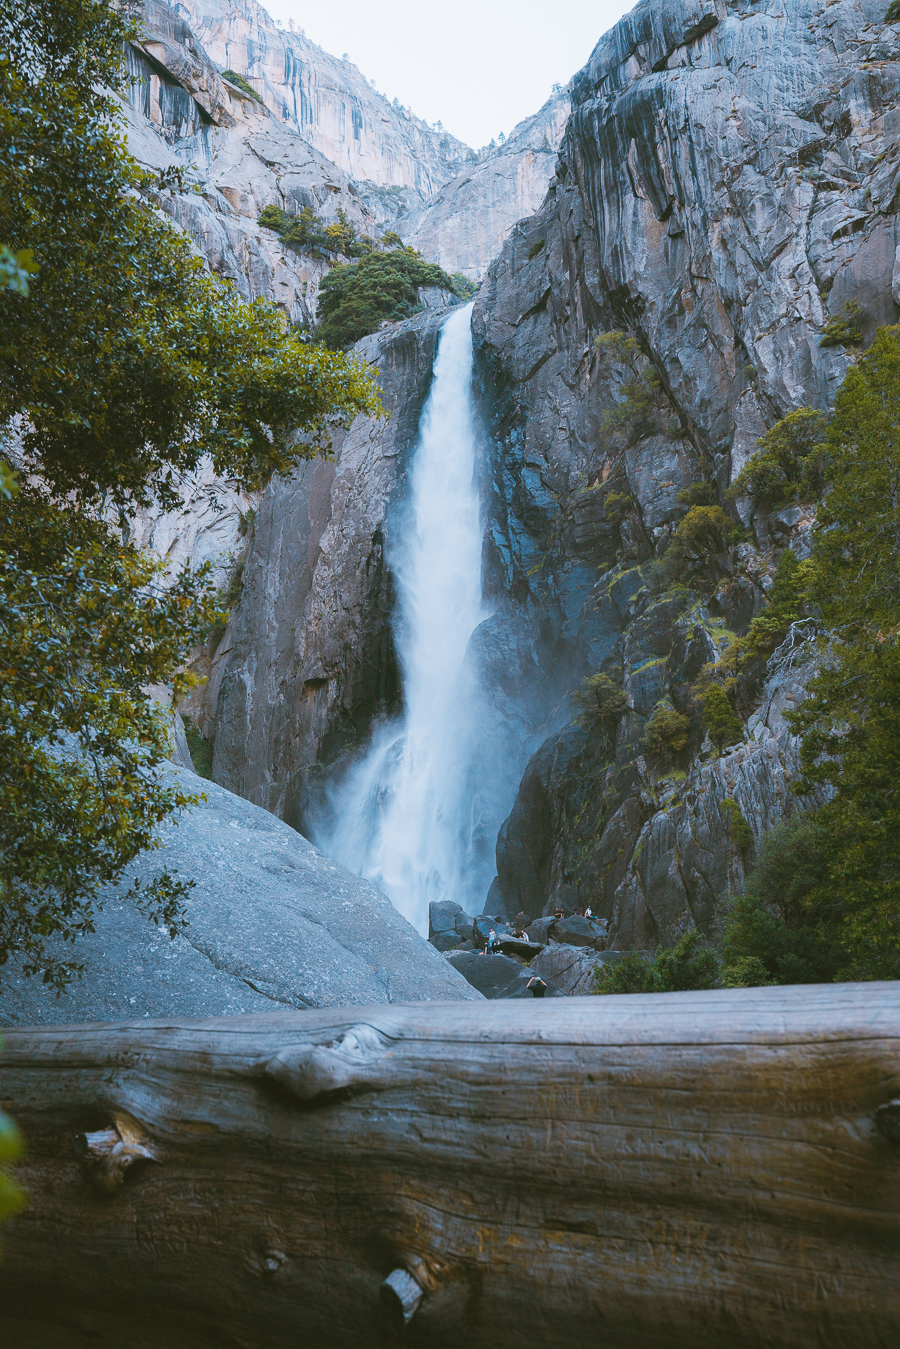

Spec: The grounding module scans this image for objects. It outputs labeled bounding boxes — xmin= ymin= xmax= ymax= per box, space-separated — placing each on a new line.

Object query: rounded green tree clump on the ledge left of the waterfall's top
xmin=316 ymin=248 xmax=452 ymax=349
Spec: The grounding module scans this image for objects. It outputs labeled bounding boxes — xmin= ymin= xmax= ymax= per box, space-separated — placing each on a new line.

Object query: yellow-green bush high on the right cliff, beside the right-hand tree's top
xmin=729 ymin=407 xmax=828 ymax=510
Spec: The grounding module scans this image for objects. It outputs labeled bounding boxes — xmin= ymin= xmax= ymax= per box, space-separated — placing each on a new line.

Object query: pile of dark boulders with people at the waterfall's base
xmin=428 ymin=900 xmax=636 ymax=998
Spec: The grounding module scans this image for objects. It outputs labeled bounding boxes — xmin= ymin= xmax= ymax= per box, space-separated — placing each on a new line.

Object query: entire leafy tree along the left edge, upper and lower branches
xmin=0 ymin=0 xmax=381 ymax=987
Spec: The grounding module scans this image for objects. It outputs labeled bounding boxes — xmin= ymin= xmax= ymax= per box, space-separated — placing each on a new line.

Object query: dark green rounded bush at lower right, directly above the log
xmin=722 ymin=815 xmax=846 ymax=989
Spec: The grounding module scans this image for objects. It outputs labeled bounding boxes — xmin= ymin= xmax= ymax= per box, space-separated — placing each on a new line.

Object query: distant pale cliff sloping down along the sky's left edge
xmin=175 ymin=0 xmax=474 ymax=201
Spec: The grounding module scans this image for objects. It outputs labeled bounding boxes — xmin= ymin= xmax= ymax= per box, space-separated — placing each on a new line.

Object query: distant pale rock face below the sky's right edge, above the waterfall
xmin=394 ymin=93 xmax=571 ymax=281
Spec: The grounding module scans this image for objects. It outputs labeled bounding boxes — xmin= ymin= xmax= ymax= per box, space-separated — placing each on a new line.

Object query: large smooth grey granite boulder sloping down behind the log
xmin=0 ymin=768 xmax=479 ymax=1025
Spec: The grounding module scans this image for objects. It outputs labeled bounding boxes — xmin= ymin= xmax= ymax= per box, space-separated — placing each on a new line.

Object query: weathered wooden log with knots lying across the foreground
xmin=0 ymin=983 xmax=900 ymax=1349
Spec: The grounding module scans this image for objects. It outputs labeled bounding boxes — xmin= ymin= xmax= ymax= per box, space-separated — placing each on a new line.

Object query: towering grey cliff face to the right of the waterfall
xmin=475 ymin=0 xmax=900 ymax=947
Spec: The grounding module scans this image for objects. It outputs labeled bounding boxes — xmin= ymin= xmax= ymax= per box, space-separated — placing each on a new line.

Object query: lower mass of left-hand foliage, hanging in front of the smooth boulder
xmin=0 ymin=487 xmax=213 ymax=987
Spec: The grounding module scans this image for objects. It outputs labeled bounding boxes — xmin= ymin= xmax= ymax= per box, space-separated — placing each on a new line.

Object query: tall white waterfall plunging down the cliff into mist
xmin=317 ymin=305 xmax=494 ymax=931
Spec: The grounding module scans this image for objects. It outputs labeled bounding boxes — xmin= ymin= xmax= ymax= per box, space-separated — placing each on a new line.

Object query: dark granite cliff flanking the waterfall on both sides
xmin=179 ymin=0 xmax=900 ymax=948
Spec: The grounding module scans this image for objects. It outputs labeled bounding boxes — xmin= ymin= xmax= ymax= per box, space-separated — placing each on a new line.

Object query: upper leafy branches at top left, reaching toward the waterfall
xmin=0 ymin=0 xmax=374 ymax=506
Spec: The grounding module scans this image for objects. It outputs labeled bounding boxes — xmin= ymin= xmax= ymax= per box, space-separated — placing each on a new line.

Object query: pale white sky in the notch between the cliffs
xmin=260 ymin=0 xmax=634 ymax=150
